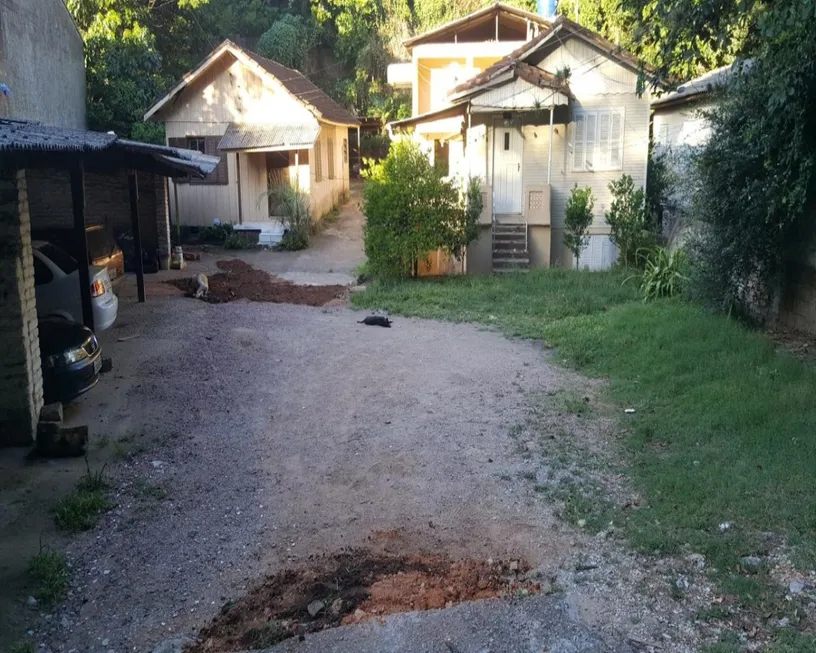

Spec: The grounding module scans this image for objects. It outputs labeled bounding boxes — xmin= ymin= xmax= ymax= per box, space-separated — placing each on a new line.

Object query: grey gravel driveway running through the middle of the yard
xmin=1 ymin=298 xmax=713 ymax=653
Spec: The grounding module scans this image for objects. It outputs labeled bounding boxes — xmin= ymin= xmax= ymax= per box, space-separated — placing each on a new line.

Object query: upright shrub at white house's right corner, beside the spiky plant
xmin=606 ymin=175 xmax=654 ymax=266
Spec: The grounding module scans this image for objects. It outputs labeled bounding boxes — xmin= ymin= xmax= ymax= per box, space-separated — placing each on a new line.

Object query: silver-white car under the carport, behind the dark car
xmin=31 ymin=240 xmax=119 ymax=331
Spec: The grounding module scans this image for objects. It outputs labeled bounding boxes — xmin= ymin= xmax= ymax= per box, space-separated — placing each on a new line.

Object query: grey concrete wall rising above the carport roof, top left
xmin=0 ymin=0 xmax=85 ymax=129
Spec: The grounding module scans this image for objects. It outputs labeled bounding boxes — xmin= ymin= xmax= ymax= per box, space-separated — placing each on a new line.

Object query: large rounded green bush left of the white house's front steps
xmin=363 ymin=140 xmax=482 ymax=278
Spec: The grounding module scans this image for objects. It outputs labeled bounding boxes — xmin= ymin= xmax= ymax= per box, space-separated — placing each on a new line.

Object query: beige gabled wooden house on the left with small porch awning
xmin=145 ymin=41 xmax=359 ymax=226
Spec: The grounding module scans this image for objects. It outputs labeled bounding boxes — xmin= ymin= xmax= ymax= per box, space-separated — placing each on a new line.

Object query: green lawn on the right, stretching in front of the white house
xmin=352 ymin=270 xmax=816 ymax=640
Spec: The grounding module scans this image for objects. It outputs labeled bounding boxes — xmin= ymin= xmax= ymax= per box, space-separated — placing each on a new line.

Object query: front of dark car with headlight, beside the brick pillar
xmin=39 ymin=317 xmax=102 ymax=404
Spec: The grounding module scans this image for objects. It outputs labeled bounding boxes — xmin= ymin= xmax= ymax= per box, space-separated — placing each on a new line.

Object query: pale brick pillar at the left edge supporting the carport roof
xmin=0 ymin=169 xmax=43 ymax=446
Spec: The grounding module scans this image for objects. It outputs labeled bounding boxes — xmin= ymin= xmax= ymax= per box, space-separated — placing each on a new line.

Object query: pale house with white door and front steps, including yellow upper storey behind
xmin=389 ymin=3 xmax=649 ymax=273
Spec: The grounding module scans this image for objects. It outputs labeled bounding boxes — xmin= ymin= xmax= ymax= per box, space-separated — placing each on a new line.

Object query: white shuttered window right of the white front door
xmin=572 ymin=109 xmax=624 ymax=171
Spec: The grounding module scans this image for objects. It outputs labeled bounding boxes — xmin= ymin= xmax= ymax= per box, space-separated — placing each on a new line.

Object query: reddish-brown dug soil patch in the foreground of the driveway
xmin=186 ymin=550 xmax=541 ymax=653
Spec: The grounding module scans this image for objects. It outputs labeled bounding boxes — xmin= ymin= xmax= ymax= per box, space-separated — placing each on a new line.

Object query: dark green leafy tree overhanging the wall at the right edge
xmin=692 ymin=0 xmax=816 ymax=321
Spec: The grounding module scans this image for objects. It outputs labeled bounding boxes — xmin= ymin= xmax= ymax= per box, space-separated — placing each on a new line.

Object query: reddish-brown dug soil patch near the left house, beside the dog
xmin=167 ymin=259 xmax=348 ymax=306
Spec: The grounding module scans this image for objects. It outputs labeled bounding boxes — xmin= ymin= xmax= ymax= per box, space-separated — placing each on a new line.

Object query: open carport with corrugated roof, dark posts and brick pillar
xmin=0 ymin=119 xmax=218 ymax=446
